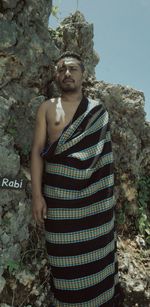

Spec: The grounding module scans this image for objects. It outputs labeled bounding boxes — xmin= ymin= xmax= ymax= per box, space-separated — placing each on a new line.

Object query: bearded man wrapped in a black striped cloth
xmin=31 ymin=52 xmax=117 ymax=307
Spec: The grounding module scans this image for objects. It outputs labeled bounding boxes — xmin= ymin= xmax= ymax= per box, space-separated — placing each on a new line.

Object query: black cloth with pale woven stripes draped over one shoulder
xmin=42 ymin=97 xmax=118 ymax=307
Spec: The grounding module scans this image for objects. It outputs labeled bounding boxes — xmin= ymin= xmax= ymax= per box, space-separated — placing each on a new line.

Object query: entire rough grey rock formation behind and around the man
xmin=0 ymin=0 xmax=150 ymax=307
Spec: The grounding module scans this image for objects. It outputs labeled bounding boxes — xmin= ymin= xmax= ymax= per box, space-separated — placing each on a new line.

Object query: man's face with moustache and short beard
xmin=56 ymin=57 xmax=83 ymax=92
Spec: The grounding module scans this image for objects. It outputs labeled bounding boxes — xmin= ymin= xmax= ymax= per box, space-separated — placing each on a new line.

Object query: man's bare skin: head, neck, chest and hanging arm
xmin=31 ymin=57 xmax=84 ymax=226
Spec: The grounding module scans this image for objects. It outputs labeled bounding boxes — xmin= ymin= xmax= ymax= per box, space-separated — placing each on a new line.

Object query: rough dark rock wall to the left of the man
xmin=0 ymin=0 xmax=54 ymax=300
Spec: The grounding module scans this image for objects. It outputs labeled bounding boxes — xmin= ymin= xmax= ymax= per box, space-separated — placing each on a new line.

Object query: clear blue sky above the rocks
xmin=49 ymin=0 xmax=150 ymax=121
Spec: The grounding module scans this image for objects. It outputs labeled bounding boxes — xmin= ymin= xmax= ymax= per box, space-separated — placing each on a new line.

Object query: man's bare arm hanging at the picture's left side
xmin=31 ymin=102 xmax=46 ymax=225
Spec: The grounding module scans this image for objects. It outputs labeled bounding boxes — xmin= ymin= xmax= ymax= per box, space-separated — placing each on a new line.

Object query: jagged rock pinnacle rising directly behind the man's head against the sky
xmin=50 ymin=11 xmax=99 ymax=75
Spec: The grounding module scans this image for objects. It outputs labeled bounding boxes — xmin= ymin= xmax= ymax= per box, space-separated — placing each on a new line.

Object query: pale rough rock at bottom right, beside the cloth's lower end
xmin=118 ymin=235 xmax=150 ymax=307
